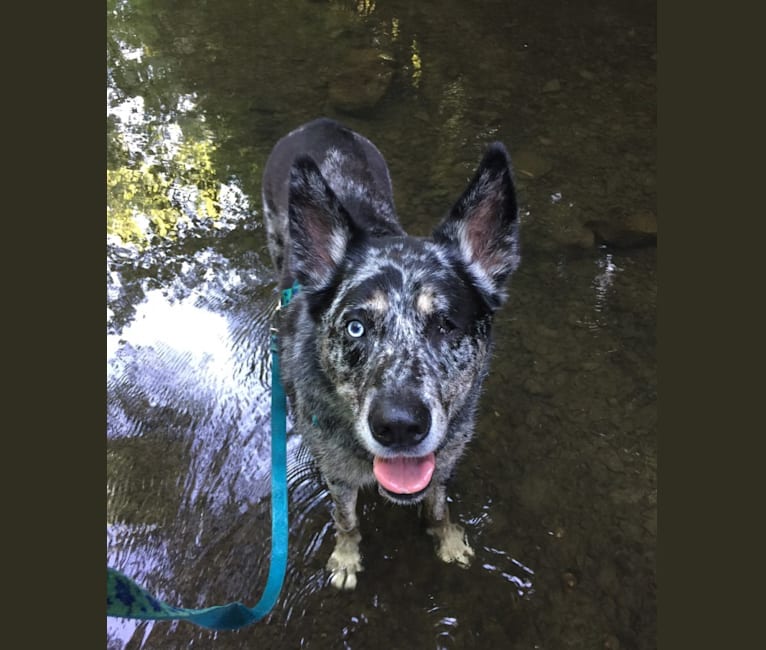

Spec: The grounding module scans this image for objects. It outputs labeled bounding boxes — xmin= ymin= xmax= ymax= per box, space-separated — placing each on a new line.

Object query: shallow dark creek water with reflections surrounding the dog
xmin=107 ymin=0 xmax=657 ymax=650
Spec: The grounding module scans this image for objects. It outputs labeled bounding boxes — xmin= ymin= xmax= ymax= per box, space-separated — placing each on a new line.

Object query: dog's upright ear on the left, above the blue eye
xmin=288 ymin=156 xmax=352 ymax=287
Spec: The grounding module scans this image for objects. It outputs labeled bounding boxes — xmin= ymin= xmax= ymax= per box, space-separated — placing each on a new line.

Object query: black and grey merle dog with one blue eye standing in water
xmin=262 ymin=118 xmax=520 ymax=589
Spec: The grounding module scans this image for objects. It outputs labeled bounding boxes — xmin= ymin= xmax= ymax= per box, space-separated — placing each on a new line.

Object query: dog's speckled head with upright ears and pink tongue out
xmin=289 ymin=143 xmax=520 ymax=503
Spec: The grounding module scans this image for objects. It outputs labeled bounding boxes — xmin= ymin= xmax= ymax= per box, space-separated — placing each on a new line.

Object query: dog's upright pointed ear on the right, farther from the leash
xmin=433 ymin=142 xmax=521 ymax=307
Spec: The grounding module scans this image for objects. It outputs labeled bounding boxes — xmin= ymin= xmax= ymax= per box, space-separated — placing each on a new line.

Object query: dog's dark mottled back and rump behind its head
xmin=262 ymin=118 xmax=404 ymax=278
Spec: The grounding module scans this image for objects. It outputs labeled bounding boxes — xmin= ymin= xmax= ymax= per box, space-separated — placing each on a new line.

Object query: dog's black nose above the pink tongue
xmin=368 ymin=395 xmax=431 ymax=448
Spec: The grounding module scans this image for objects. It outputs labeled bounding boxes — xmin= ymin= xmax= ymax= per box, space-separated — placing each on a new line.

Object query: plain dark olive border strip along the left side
xmin=19 ymin=3 xmax=106 ymax=648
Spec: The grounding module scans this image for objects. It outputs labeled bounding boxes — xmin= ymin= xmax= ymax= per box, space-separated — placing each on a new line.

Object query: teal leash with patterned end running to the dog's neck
xmin=106 ymin=283 xmax=300 ymax=630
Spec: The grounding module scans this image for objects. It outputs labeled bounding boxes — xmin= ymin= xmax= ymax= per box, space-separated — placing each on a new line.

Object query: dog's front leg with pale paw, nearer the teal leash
xmin=327 ymin=483 xmax=363 ymax=589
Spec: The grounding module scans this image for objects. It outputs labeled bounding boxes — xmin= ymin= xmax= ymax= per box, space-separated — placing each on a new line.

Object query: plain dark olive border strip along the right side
xmin=657 ymin=3 xmax=766 ymax=650
